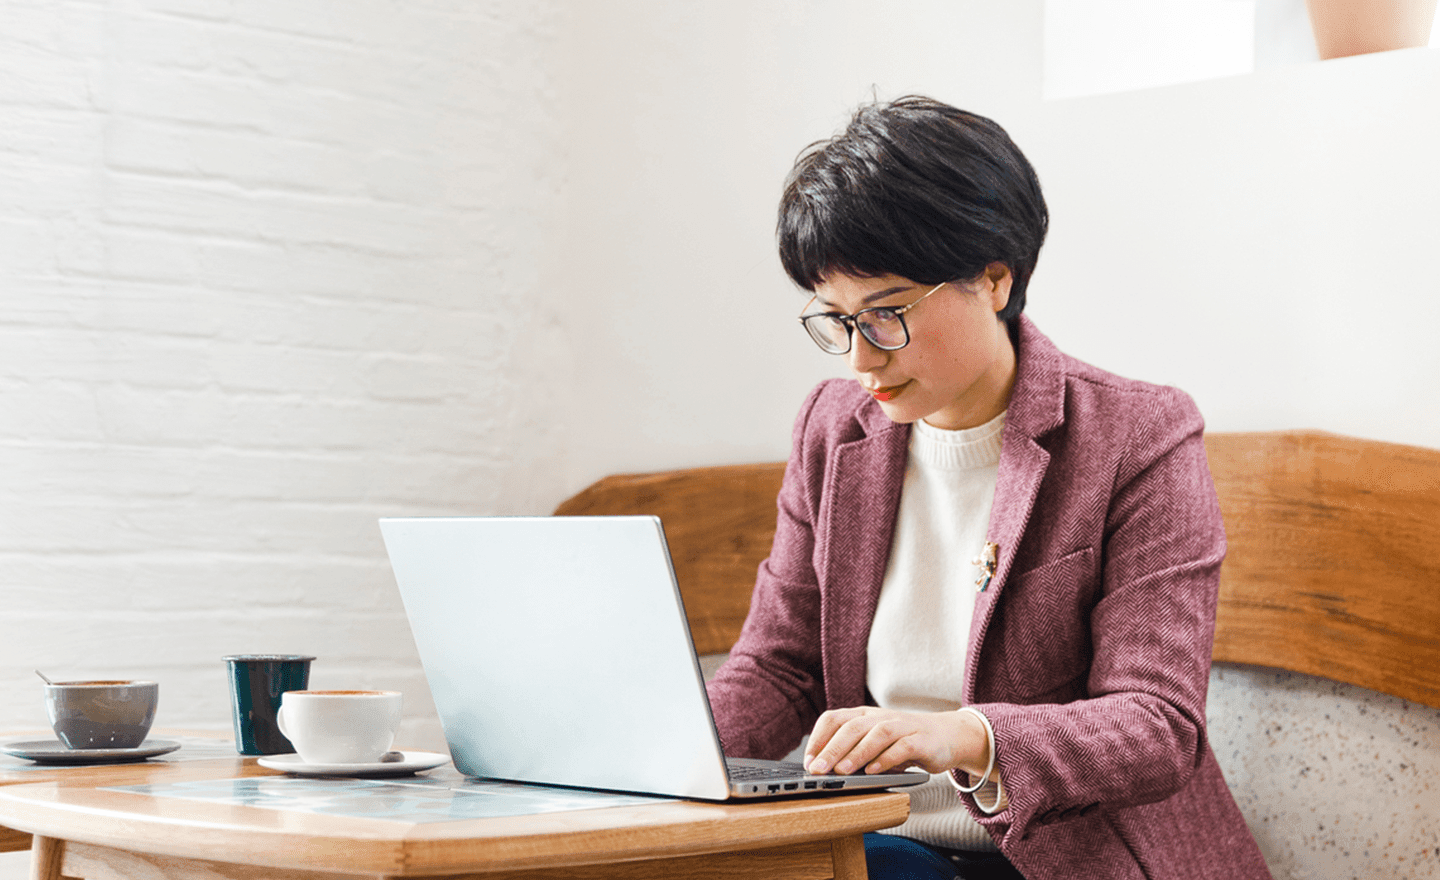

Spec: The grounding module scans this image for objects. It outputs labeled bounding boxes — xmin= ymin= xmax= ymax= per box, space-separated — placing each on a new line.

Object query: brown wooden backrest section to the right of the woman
xmin=1205 ymin=431 xmax=1440 ymax=707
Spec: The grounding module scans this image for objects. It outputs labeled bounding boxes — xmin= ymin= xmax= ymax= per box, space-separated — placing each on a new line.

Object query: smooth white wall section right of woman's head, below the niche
xmin=1020 ymin=49 xmax=1440 ymax=446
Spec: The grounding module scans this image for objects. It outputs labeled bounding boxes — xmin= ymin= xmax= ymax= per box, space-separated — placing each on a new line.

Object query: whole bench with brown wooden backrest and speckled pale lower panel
xmin=556 ymin=431 xmax=1440 ymax=879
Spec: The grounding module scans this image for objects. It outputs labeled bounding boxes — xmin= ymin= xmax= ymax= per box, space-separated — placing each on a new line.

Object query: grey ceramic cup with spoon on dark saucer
xmin=45 ymin=681 xmax=160 ymax=749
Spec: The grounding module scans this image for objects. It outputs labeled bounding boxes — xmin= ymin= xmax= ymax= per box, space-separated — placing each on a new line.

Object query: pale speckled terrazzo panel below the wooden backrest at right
xmin=1208 ymin=664 xmax=1440 ymax=880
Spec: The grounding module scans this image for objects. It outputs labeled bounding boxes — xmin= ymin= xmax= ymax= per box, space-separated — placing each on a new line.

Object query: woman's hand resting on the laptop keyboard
xmin=805 ymin=706 xmax=989 ymax=776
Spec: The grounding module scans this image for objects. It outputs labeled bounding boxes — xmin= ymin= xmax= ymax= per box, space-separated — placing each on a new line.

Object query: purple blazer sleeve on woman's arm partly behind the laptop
xmin=707 ymin=383 xmax=825 ymax=759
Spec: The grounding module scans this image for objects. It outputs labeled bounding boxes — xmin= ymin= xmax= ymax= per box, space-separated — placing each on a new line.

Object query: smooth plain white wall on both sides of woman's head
xmin=550 ymin=0 xmax=1440 ymax=488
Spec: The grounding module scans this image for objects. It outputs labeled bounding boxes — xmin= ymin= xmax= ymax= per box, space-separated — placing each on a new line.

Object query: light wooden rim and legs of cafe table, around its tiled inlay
xmin=0 ymin=759 xmax=910 ymax=880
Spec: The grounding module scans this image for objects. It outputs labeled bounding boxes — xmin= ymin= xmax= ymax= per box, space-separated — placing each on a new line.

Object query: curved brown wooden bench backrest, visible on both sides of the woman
xmin=556 ymin=431 xmax=1440 ymax=707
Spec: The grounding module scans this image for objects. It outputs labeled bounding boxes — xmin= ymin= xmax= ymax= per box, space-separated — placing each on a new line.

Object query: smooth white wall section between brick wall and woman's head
xmin=549 ymin=0 xmax=1041 ymax=490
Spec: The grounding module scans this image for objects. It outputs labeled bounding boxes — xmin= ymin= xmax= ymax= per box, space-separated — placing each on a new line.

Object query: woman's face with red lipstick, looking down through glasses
xmin=808 ymin=264 xmax=1015 ymax=431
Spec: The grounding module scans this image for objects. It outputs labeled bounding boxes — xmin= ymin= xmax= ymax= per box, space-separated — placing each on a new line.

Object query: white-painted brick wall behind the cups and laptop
xmin=0 ymin=0 xmax=564 ymax=747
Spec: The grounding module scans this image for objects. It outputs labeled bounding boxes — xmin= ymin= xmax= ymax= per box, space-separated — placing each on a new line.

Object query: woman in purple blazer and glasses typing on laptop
xmin=710 ymin=98 xmax=1269 ymax=880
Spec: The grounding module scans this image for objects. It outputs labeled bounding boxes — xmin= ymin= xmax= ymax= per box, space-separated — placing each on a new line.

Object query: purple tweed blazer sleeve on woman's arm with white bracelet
xmin=973 ymin=389 xmax=1225 ymax=835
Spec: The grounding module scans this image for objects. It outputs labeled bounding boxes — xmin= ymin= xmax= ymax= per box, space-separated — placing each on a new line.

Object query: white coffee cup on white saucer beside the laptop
xmin=275 ymin=690 xmax=400 ymax=763
